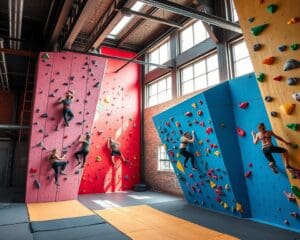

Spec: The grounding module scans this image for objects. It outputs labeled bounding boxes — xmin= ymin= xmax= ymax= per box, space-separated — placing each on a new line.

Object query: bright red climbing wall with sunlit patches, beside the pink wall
xmin=79 ymin=48 xmax=141 ymax=193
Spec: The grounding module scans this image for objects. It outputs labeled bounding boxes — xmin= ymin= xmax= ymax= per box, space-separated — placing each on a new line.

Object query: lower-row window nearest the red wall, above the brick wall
xmin=146 ymin=76 xmax=172 ymax=107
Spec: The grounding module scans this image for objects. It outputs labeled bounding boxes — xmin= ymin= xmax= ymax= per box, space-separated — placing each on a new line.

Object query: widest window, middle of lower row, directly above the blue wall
xmin=180 ymin=54 xmax=220 ymax=95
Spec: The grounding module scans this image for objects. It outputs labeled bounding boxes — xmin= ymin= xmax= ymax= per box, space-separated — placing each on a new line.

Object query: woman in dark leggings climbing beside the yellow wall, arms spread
xmin=251 ymin=123 xmax=294 ymax=174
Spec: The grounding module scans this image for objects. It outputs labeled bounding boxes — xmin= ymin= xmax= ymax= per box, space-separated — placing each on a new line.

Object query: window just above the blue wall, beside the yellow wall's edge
xmin=231 ymin=40 xmax=253 ymax=77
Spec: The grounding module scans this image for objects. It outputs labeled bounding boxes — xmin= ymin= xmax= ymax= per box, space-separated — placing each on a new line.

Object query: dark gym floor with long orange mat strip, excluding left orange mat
xmin=0 ymin=191 xmax=300 ymax=240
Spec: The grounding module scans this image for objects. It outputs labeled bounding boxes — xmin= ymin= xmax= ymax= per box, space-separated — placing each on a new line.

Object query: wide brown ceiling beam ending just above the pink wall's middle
xmin=62 ymin=0 xmax=97 ymax=49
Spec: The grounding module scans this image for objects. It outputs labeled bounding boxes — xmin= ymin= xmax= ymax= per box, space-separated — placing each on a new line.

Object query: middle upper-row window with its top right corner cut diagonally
xmin=180 ymin=20 xmax=208 ymax=52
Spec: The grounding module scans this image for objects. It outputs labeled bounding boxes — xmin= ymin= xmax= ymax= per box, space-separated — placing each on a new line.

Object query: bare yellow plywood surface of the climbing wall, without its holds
xmin=234 ymin=0 xmax=300 ymax=206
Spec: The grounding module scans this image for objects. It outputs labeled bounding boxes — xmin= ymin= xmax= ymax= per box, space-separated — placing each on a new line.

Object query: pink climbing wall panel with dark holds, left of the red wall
xmin=26 ymin=52 xmax=106 ymax=202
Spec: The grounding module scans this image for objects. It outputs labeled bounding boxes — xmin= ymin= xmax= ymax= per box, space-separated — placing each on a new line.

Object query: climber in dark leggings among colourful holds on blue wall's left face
xmin=179 ymin=131 xmax=198 ymax=170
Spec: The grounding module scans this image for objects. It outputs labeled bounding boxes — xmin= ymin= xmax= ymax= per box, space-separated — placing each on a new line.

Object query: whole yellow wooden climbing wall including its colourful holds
xmin=234 ymin=0 xmax=300 ymax=206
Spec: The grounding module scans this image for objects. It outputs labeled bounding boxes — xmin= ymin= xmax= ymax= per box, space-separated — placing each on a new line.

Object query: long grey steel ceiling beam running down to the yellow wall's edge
xmin=140 ymin=0 xmax=242 ymax=33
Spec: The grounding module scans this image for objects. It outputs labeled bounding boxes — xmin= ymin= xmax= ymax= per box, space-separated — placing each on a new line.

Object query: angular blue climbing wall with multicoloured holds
xmin=153 ymin=74 xmax=300 ymax=231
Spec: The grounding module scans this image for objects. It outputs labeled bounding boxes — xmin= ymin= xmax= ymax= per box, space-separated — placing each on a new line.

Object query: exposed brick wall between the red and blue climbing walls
xmin=144 ymin=92 xmax=204 ymax=195
